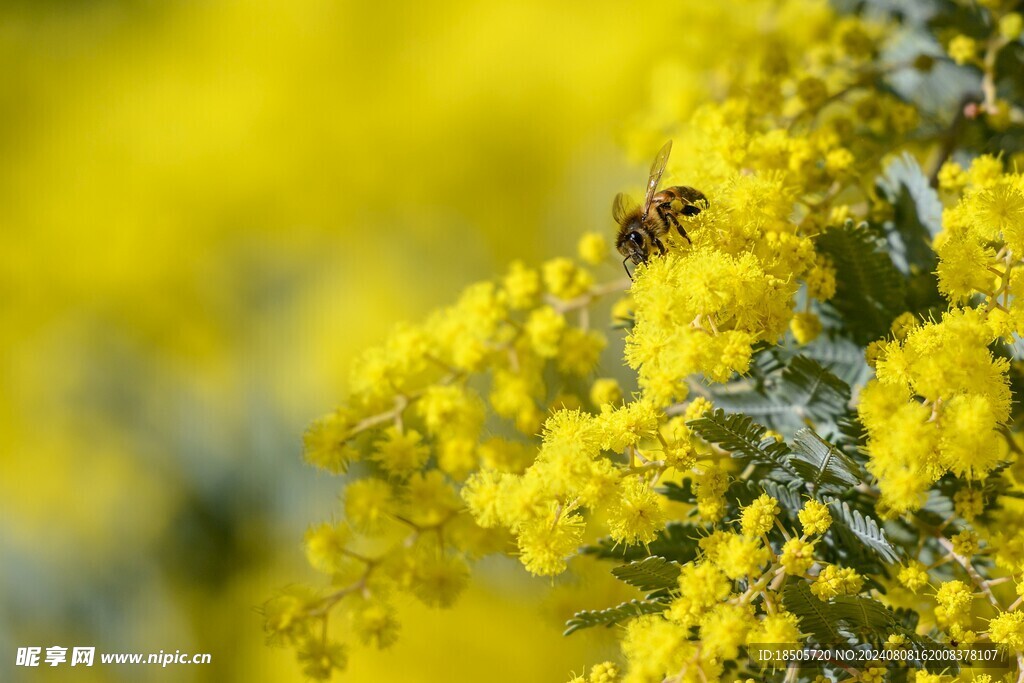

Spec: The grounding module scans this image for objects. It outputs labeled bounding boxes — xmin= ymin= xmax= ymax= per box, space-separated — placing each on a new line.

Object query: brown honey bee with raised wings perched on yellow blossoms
xmin=611 ymin=140 xmax=708 ymax=280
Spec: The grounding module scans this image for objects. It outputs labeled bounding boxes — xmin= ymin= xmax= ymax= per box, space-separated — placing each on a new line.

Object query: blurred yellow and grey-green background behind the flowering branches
xmin=0 ymin=0 xmax=713 ymax=683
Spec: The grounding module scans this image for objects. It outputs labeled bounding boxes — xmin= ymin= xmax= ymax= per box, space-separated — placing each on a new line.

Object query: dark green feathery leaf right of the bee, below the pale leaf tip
xmin=817 ymin=221 xmax=905 ymax=345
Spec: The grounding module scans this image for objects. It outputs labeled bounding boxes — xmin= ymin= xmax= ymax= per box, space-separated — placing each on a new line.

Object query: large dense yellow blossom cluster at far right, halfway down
xmin=858 ymin=308 xmax=1010 ymax=512
